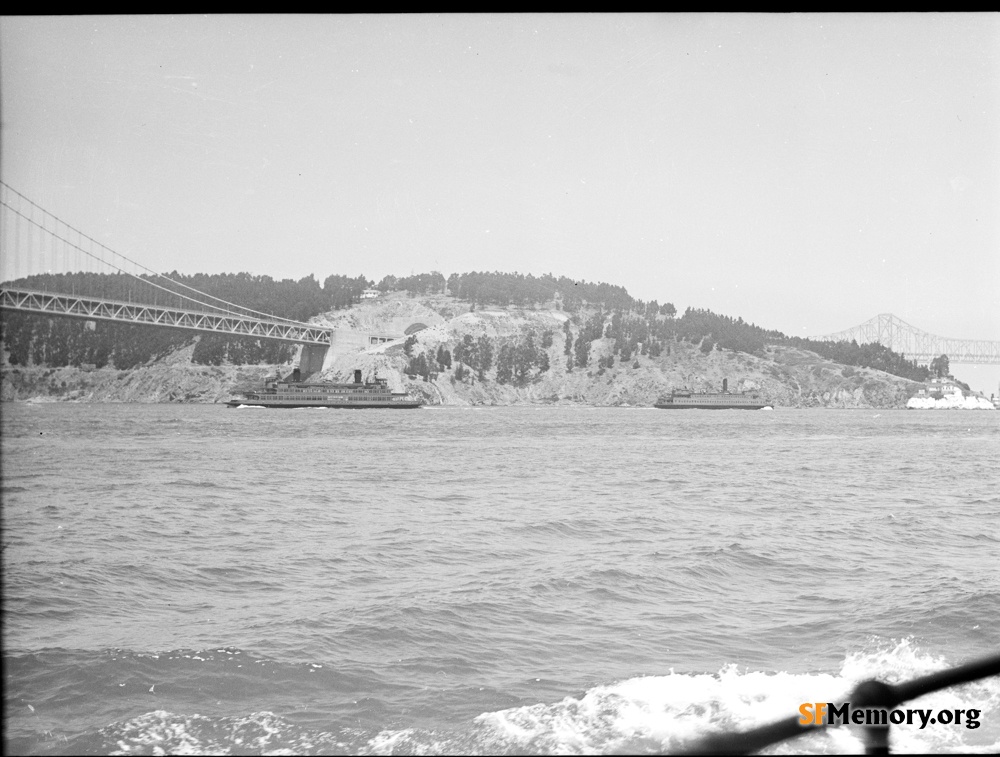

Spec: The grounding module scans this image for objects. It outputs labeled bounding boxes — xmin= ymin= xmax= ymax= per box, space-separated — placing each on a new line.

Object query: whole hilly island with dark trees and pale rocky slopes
xmin=0 ymin=272 xmax=967 ymax=408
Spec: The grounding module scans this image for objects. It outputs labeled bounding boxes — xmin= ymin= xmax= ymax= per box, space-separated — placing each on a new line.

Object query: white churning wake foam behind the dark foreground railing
xmin=90 ymin=640 xmax=1000 ymax=754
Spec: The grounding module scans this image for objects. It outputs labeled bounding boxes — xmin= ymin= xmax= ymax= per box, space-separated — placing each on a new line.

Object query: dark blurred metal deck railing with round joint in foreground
xmin=678 ymin=654 xmax=1000 ymax=755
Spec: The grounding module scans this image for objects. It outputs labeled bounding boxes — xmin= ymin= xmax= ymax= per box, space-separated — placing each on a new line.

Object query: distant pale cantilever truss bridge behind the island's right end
xmin=809 ymin=313 xmax=1000 ymax=365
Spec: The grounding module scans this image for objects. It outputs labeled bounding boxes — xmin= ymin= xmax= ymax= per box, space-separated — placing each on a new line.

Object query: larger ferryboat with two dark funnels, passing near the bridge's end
xmin=226 ymin=368 xmax=424 ymax=410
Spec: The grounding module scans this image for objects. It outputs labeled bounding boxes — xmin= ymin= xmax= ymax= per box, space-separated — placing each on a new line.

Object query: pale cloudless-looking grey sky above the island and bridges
xmin=0 ymin=13 xmax=1000 ymax=392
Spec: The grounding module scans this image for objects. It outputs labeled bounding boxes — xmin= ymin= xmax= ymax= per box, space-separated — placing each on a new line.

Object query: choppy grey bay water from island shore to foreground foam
xmin=2 ymin=403 xmax=1000 ymax=754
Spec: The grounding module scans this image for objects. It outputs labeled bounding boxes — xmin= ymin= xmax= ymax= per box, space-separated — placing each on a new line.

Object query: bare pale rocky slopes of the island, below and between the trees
xmin=0 ymin=294 xmax=919 ymax=408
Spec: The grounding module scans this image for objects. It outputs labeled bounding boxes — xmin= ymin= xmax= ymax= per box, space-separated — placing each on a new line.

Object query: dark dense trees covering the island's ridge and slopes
xmin=0 ymin=271 xmax=936 ymax=384
